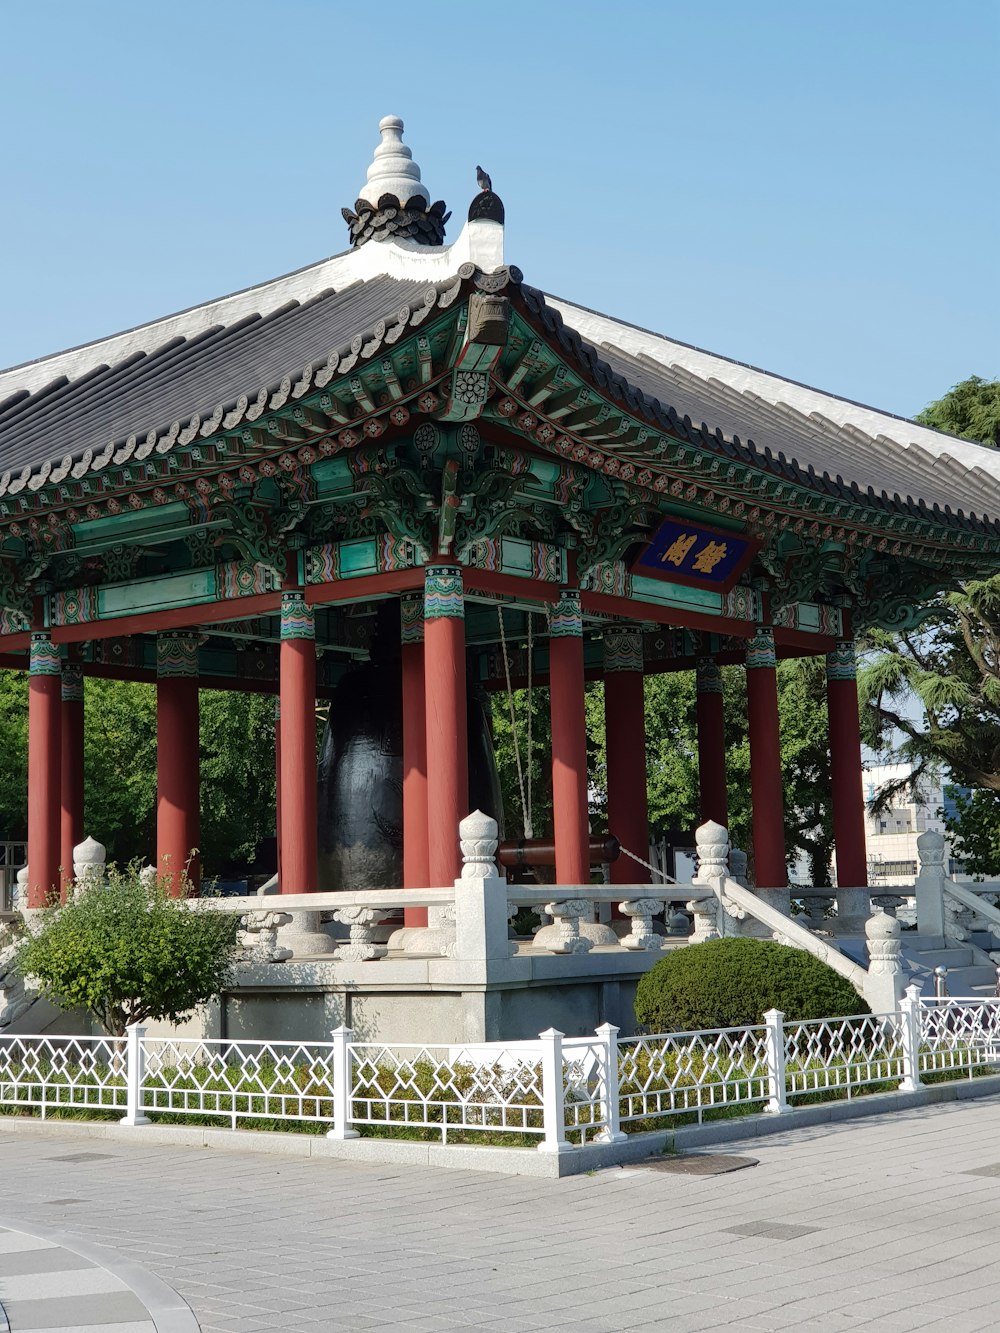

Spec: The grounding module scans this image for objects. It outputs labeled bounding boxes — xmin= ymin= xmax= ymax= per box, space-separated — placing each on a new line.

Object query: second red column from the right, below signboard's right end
xmin=747 ymin=627 xmax=788 ymax=890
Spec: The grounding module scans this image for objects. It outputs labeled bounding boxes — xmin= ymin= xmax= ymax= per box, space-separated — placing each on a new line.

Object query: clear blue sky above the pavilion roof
xmin=0 ymin=0 xmax=1000 ymax=415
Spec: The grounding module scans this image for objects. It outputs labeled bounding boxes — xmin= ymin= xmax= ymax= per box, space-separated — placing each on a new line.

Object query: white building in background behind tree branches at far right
xmin=864 ymin=764 xmax=968 ymax=886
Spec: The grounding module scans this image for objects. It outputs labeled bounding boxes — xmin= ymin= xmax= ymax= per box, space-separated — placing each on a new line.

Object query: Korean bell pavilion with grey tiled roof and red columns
xmin=0 ymin=116 xmax=1000 ymax=925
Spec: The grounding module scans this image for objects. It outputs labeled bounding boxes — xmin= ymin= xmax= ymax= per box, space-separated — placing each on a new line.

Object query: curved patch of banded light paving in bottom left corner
xmin=0 ymin=1221 xmax=199 ymax=1333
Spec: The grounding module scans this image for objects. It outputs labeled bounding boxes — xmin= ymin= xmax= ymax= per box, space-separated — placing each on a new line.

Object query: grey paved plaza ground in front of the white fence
xmin=0 ymin=1100 xmax=1000 ymax=1333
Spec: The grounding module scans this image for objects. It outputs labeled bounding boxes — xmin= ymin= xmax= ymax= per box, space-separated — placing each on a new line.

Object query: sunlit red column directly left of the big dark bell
xmin=277 ymin=589 xmax=319 ymax=893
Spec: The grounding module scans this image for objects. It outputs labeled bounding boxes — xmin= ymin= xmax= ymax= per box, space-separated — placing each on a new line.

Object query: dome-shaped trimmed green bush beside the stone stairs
xmin=636 ymin=938 xmax=871 ymax=1032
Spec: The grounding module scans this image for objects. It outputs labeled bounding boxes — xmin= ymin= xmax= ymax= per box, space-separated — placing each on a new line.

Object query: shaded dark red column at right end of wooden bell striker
xmin=602 ymin=627 xmax=649 ymax=884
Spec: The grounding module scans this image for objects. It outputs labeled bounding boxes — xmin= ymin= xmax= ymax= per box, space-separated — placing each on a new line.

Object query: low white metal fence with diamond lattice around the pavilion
xmin=0 ymin=989 xmax=1000 ymax=1152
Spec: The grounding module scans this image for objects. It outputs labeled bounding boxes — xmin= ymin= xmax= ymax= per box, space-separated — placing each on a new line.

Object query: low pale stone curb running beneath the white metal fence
xmin=0 ymin=1074 xmax=1000 ymax=1183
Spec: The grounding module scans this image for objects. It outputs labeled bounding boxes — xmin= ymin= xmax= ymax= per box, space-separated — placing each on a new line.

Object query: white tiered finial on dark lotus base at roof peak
xmin=340 ymin=116 xmax=451 ymax=249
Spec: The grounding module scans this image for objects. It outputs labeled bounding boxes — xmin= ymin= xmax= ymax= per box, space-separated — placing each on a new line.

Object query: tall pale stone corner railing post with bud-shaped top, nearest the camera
xmin=455 ymin=810 xmax=517 ymax=962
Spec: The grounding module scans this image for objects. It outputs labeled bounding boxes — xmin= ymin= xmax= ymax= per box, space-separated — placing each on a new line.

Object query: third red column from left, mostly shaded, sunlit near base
xmin=156 ymin=631 xmax=201 ymax=896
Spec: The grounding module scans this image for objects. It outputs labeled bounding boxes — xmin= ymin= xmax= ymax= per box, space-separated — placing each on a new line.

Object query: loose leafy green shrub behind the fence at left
xmin=17 ymin=862 xmax=239 ymax=1037
